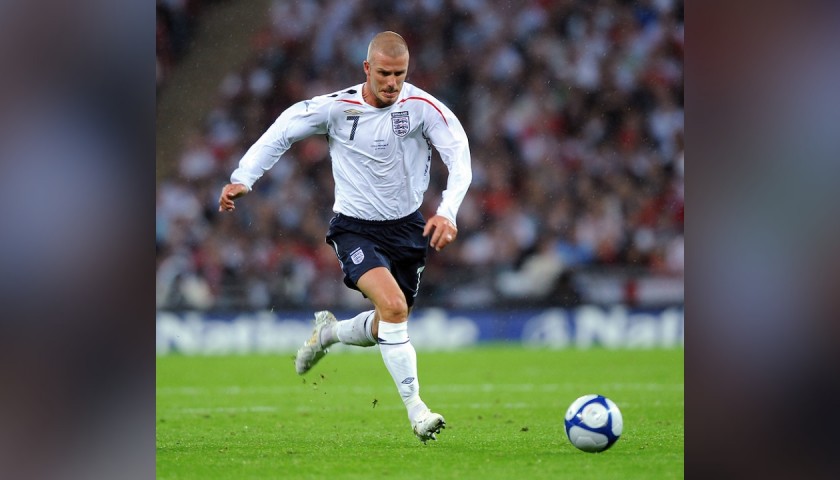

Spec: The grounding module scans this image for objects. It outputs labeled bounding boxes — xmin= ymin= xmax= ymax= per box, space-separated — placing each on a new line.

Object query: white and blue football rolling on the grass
xmin=566 ymin=394 xmax=624 ymax=453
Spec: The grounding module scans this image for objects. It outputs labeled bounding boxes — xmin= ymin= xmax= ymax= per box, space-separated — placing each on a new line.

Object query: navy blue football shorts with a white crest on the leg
xmin=327 ymin=211 xmax=428 ymax=307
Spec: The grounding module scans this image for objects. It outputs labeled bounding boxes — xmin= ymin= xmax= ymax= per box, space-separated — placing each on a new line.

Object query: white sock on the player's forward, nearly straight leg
xmin=379 ymin=322 xmax=428 ymax=422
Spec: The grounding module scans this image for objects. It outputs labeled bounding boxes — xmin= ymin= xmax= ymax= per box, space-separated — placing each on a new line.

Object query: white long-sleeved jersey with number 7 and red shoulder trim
xmin=230 ymin=82 xmax=472 ymax=224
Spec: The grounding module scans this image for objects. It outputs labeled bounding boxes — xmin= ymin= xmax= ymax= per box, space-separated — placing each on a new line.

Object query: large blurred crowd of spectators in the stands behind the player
xmin=155 ymin=0 xmax=684 ymax=310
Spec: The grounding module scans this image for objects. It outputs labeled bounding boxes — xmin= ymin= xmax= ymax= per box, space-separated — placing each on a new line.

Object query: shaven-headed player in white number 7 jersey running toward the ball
xmin=219 ymin=32 xmax=472 ymax=443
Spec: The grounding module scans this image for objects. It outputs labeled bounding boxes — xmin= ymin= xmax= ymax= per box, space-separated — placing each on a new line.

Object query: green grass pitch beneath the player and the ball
xmin=156 ymin=344 xmax=685 ymax=480
